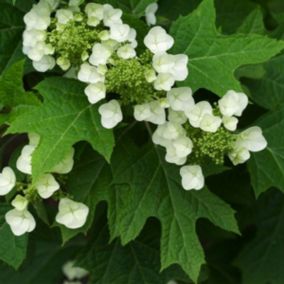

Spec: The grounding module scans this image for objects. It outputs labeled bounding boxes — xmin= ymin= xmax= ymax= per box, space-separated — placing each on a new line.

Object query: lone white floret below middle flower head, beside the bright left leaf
xmin=99 ymin=100 xmax=122 ymax=129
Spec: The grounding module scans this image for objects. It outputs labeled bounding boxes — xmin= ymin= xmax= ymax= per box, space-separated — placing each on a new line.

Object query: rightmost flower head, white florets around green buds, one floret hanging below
xmin=153 ymin=90 xmax=267 ymax=190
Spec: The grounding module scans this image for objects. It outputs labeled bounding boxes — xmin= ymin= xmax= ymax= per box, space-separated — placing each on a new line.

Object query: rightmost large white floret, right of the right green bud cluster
xmin=236 ymin=126 xmax=267 ymax=152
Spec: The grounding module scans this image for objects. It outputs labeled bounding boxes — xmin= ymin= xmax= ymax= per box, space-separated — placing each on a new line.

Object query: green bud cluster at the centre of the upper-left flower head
xmin=47 ymin=14 xmax=101 ymax=66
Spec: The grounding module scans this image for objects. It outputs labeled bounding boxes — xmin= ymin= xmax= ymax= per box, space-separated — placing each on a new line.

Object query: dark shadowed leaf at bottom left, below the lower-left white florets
xmin=0 ymin=224 xmax=80 ymax=284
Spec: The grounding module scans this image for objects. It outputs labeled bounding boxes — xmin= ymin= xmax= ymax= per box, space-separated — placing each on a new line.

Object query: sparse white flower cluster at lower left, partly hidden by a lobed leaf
xmin=0 ymin=134 xmax=89 ymax=236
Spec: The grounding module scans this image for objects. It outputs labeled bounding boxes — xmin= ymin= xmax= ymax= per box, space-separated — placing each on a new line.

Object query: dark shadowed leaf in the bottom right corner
xmin=237 ymin=191 xmax=284 ymax=284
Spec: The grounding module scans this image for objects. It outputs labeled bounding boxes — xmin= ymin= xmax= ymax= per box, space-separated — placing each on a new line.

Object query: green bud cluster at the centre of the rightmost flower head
xmin=188 ymin=127 xmax=235 ymax=165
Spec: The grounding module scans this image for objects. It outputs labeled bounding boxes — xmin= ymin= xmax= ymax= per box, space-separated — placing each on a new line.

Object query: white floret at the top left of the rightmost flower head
xmin=167 ymin=87 xmax=195 ymax=112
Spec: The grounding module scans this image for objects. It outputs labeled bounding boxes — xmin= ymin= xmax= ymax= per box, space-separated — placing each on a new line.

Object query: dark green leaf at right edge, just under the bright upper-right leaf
xmin=244 ymin=55 xmax=284 ymax=110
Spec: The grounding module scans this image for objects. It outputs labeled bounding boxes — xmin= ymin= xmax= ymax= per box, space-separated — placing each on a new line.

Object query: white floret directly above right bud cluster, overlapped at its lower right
xmin=185 ymin=101 xmax=213 ymax=128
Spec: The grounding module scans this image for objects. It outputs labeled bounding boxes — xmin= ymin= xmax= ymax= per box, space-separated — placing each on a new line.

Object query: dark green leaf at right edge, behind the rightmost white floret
xmin=248 ymin=108 xmax=284 ymax=196
